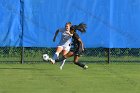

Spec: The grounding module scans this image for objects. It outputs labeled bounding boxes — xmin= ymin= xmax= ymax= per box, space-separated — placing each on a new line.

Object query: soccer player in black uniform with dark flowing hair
xmin=51 ymin=23 xmax=88 ymax=69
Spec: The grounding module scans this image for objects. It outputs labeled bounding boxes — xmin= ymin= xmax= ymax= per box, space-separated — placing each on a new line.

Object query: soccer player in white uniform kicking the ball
xmin=50 ymin=22 xmax=73 ymax=63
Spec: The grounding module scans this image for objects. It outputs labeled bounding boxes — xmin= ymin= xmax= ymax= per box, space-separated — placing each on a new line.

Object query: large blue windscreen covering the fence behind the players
xmin=0 ymin=0 xmax=140 ymax=48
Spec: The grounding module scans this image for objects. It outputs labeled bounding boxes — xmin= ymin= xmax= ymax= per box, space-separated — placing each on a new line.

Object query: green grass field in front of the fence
xmin=0 ymin=63 xmax=140 ymax=93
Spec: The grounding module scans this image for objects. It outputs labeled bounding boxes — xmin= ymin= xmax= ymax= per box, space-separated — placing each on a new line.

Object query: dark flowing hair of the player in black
xmin=70 ymin=23 xmax=87 ymax=33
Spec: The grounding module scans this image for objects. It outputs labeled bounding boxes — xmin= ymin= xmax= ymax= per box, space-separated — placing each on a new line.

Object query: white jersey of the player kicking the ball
xmin=59 ymin=28 xmax=72 ymax=46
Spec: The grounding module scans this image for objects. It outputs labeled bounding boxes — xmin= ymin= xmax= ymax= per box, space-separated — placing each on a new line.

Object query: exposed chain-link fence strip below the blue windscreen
xmin=0 ymin=47 xmax=140 ymax=63
